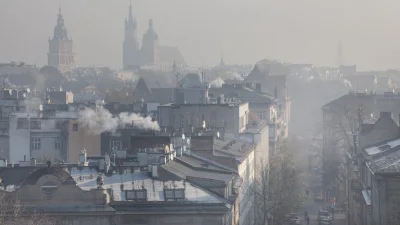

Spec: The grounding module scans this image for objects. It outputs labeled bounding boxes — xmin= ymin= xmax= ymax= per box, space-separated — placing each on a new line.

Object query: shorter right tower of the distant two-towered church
xmin=140 ymin=19 xmax=159 ymax=66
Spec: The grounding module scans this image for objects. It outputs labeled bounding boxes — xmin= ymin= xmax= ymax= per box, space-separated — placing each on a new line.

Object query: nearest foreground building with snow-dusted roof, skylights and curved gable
xmin=0 ymin=144 xmax=239 ymax=225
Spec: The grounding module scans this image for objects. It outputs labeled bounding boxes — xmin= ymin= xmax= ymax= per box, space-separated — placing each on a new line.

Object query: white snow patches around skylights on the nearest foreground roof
xmin=71 ymin=168 xmax=222 ymax=203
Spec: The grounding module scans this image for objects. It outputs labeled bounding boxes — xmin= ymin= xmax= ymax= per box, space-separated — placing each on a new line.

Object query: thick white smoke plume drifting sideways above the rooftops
xmin=79 ymin=106 xmax=160 ymax=134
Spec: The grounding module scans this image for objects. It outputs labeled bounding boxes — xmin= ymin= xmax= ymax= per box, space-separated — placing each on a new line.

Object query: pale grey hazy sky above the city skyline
xmin=0 ymin=0 xmax=400 ymax=69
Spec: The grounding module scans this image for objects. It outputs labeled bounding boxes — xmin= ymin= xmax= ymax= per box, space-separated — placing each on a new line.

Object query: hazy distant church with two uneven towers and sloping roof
xmin=123 ymin=4 xmax=185 ymax=69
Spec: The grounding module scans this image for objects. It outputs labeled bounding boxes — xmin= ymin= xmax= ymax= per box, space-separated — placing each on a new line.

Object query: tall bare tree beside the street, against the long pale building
xmin=251 ymin=143 xmax=303 ymax=225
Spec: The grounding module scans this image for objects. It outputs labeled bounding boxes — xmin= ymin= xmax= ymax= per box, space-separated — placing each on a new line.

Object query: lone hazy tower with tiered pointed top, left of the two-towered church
xmin=47 ymin=8 xmax=75 ymax=73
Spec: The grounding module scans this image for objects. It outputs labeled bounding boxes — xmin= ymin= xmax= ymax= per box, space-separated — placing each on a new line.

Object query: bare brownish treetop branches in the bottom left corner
xmin=0 ymin=192 xmax=58 ymax=225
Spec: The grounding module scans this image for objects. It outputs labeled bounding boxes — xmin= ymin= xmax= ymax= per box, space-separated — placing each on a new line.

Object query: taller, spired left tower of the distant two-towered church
xmin=123 ymin=3 xmax=140 ymax=69
